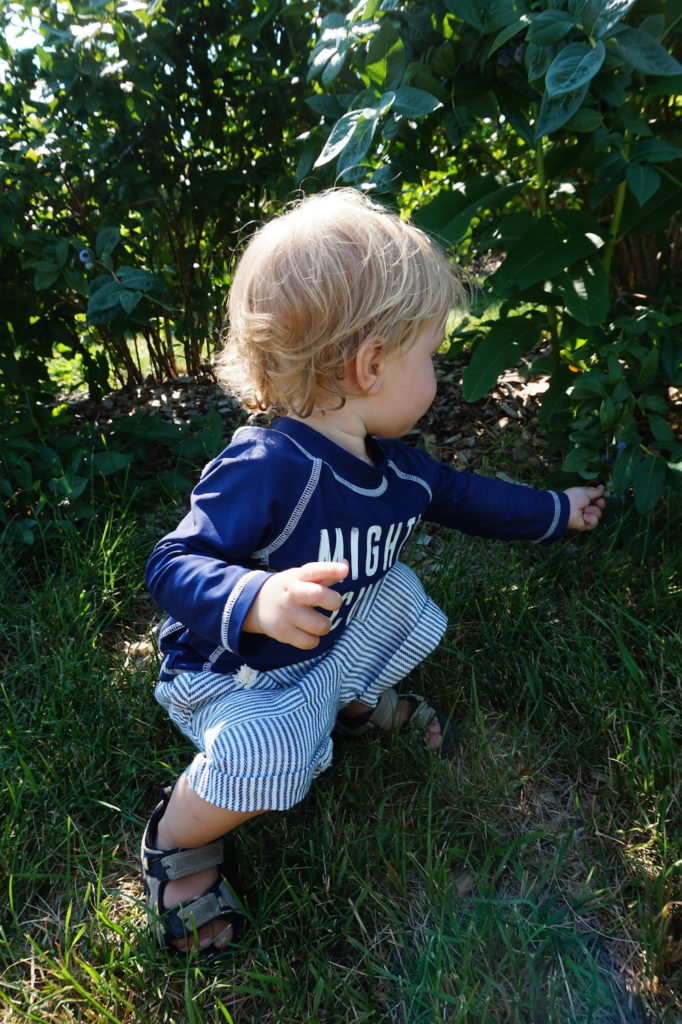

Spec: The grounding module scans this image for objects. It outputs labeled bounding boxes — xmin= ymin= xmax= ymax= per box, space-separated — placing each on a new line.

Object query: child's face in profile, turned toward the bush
xmin=368 ymin=318 xmax=445 ymax=437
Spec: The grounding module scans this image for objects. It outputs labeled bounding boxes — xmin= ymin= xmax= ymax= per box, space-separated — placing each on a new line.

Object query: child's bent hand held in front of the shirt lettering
xmin=243 ymin=562 xmax=348 ymax=650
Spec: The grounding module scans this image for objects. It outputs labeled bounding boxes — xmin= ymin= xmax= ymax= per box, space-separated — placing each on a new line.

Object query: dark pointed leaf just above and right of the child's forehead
xmin=414 ymin=174 xmax=524 ymax=244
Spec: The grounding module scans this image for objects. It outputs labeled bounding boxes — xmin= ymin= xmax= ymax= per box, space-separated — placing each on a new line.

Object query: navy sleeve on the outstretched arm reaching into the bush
xmin=413 ymin=455 xmax=570 ymax=544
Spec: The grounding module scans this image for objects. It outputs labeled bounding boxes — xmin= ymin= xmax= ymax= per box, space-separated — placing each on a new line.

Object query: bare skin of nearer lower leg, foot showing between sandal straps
xmin=157 ymin=775 xmax=263 ymax=950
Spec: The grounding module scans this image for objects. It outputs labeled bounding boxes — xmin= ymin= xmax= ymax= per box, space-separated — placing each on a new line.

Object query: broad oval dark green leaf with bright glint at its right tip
xmin=491 ymin=210 xmax=603 ymax=298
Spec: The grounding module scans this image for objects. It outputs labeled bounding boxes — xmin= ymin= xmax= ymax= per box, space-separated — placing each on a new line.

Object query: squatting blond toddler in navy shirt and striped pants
xmin=142 ymin=188 xmax=604 ymax=952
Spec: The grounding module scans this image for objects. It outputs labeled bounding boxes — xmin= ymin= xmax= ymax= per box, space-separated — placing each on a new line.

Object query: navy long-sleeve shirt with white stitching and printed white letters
xmin=146 ymin=418 xmax=569 ymax=679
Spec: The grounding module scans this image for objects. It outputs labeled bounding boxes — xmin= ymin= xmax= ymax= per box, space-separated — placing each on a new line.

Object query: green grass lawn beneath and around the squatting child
xmin=0 ymin=503 xmax=682 ymax=1024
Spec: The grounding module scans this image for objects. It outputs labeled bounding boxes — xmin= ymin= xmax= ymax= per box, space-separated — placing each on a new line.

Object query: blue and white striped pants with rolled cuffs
xmin=156 ymin=562 xmax=446 ymax=811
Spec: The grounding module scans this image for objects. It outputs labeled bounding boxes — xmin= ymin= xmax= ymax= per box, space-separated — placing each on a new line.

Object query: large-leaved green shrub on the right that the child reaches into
xmin=308 ymin=0 xmax=682 ymax=514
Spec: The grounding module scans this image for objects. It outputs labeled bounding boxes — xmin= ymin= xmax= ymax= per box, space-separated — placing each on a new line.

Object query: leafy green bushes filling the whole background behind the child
xmin=0 ymin=0 xmax=682 ymax=552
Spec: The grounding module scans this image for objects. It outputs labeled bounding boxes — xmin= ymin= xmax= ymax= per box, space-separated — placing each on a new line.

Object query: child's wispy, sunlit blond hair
xmin=215 ymin=188 xmax=464 ymax=417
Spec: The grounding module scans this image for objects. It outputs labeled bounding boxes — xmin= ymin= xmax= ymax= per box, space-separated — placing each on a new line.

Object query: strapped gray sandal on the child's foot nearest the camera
xmin=140 ymin=788 xmax=246 ymax=955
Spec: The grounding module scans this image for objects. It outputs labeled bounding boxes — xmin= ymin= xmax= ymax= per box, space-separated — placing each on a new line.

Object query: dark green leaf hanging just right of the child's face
xmin=462 ymin=314 xmax=545 ymax=401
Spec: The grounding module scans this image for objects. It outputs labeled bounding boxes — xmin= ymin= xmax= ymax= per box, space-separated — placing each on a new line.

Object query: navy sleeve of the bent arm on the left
xmin=146 ymin=432 xmax=296 ymax=653
